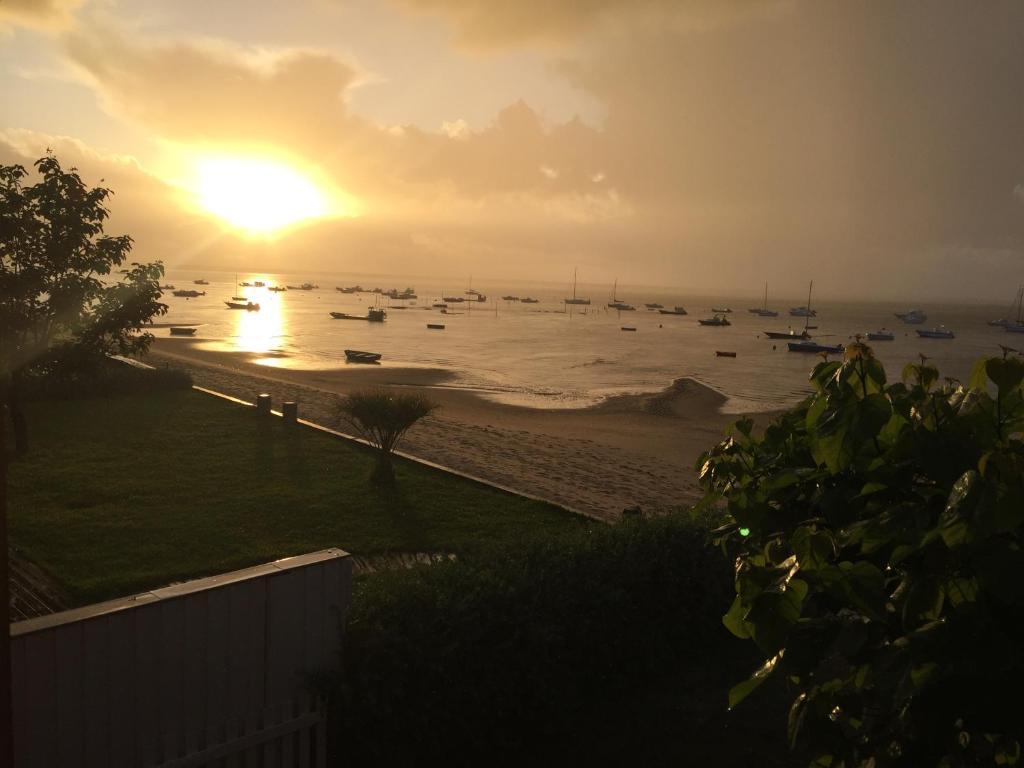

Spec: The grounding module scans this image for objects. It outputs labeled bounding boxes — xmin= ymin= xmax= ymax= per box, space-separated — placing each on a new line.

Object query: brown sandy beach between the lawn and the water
xmin=146 ymin=338 xmax=765 ymax=520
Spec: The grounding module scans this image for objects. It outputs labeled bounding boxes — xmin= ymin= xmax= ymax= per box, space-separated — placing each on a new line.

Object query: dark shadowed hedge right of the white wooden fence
xmin=323 ymin=517 xmax=784 ymax=765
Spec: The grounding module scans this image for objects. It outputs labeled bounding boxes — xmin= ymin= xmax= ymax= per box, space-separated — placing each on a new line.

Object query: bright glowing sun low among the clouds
xmin=195 ymin=157 xmax=330 ymax=234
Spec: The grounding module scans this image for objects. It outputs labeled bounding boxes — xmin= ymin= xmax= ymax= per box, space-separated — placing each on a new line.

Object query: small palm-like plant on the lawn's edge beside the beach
xmin=338 ymin=390 xmax=437 ymax=485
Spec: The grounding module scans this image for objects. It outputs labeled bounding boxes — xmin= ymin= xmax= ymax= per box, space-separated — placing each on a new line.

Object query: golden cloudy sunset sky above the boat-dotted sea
xmin=0 ymin=0 xmax=1024 ymax=306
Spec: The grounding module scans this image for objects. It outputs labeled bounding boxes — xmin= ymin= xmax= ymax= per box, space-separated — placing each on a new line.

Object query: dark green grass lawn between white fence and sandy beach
xmin=10 ymin=390 xmax=597 ymax=604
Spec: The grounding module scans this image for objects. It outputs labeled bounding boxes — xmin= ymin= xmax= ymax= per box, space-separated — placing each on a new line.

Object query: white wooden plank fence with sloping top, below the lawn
xmin=11 ymin=550 xmax=351 ymax=768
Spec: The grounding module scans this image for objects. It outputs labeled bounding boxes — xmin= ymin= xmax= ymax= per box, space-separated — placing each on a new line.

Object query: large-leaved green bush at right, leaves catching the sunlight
xmin=701 ymin=343 xmax=1024 ymax=767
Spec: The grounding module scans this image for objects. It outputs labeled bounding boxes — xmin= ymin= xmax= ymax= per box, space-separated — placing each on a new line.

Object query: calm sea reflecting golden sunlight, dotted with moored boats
xmin=155 ymin=270 xmax=1024 ymax=413
